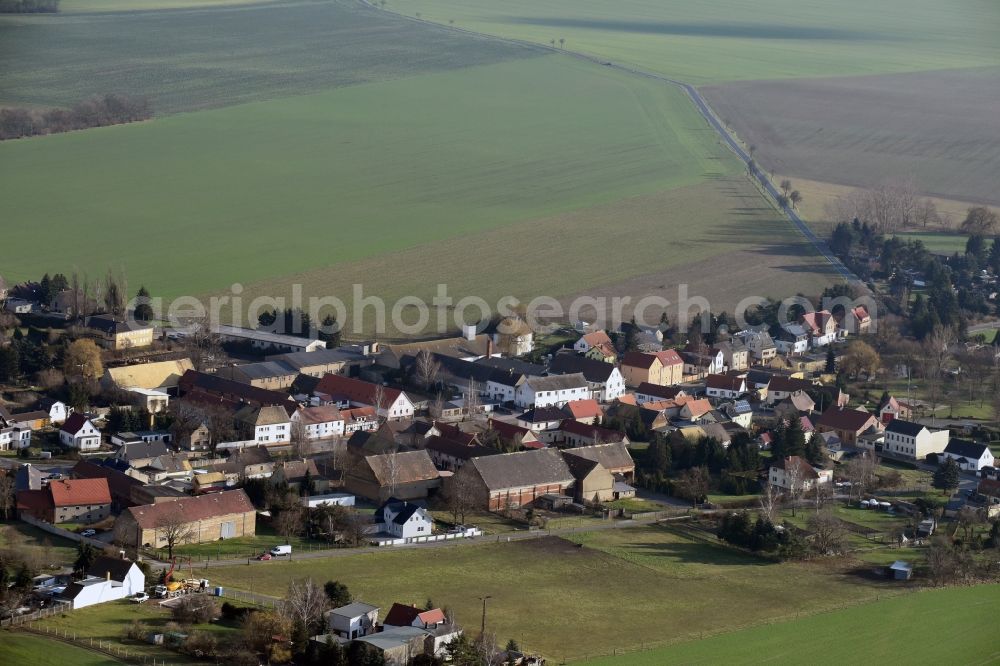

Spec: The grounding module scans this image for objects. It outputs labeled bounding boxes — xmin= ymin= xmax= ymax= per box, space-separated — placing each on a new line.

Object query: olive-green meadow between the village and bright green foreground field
xmin=211 ymin=526 xmax=893 ymax=660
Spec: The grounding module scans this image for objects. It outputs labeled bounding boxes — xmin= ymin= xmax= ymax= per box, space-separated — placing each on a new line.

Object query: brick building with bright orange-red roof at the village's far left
xmin=17 ymin=479 xmax=111 ymax=524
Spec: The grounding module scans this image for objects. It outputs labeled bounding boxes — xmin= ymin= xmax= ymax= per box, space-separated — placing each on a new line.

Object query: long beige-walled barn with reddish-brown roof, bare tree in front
xmin=115 ymin=490 xmax=257 ymax=548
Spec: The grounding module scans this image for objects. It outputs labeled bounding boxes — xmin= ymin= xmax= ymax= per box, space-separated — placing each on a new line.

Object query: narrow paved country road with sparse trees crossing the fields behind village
xmin=358 ymin=0 xmax=868 ymax=282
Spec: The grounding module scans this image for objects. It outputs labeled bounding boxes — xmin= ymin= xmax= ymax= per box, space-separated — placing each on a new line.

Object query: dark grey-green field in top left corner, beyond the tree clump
xmin=0 ymin=0 xmax=539 ymax=111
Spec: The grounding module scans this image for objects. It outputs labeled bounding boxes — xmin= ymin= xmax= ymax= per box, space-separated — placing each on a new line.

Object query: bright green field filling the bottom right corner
xmin=586 ymin=585 xmax=1000 ymax=666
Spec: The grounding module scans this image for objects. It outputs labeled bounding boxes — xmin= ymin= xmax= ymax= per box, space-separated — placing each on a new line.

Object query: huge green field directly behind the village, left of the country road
xmin=0 ymin=56 xmax=830 ymax=332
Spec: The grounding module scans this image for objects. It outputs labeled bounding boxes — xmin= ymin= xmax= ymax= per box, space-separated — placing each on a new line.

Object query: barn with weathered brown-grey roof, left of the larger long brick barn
xmin=344 ymin=449 xmax=441 ymax=502
